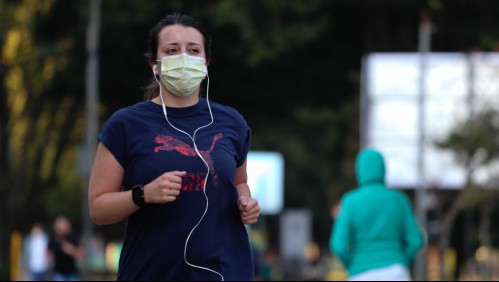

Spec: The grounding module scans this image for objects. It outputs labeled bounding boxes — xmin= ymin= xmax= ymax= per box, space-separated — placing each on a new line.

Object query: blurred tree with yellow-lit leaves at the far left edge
xmin=0 ymin=0 xmax=84 ymax=278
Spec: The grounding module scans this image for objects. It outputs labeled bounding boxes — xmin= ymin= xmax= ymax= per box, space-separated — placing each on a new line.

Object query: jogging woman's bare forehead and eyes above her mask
xmin=156 ymin=25 xmax=206 ymax=60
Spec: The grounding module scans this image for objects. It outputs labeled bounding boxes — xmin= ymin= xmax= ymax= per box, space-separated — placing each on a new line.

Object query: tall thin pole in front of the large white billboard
xmin=414 ymin=9 xmax=431 ymax=281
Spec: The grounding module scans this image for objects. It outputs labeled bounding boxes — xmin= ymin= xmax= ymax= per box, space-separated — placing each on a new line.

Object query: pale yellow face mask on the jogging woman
xmin=157 ymin=53 xmax=208 ymax=97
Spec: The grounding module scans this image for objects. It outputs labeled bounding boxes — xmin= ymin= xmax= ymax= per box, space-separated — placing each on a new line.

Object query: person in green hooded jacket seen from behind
xmin=329 ymin=148 xmax=425 ymax=281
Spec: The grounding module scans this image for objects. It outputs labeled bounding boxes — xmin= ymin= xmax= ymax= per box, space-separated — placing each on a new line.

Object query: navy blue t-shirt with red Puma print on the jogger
xmin=98 ymin=99 xmax=253 ymax=281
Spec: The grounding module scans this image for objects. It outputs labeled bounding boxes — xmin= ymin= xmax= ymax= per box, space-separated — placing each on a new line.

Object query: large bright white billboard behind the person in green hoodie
xmin=361 ymin=53 xmax=499 ymax=188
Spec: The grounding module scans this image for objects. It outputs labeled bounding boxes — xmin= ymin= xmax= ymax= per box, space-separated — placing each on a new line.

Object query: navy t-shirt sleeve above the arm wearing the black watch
xmin=97 ymin=112 xmax=126 ymax=167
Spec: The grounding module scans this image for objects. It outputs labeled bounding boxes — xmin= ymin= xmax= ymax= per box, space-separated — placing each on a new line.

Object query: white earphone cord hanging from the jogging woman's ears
xmin=153 ymin=65 xmax=224 ymax=281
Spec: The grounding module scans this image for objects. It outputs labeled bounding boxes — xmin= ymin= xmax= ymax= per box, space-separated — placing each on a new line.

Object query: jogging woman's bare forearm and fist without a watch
xmin=234 ymin=161 xmax=260 ymax=224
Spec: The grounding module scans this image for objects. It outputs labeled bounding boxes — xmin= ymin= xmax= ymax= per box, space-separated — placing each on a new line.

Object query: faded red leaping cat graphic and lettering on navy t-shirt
xmin=154 ymin=132 xmax=223 ymax=191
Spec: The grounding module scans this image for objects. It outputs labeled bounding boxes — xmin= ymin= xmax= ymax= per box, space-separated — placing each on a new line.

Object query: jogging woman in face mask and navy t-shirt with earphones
xmin=89 ymin=14 xmax=260 ymax=280
